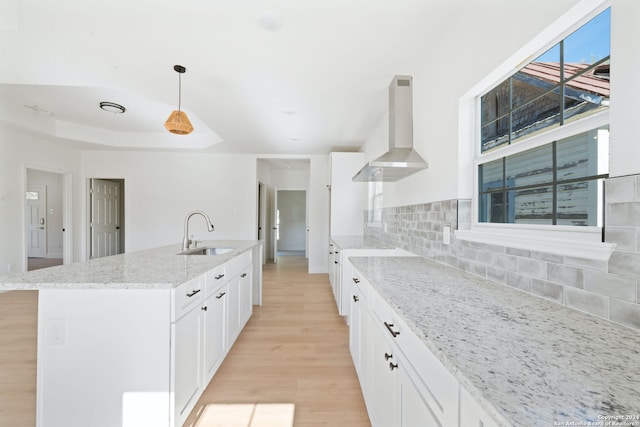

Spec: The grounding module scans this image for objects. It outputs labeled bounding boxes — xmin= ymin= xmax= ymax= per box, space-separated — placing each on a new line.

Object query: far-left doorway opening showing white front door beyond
xmin=25 ymin=168 xmax=68 ymax=271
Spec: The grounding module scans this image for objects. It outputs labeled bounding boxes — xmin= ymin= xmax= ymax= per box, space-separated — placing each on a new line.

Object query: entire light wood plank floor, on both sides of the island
xmin=0 ymin=257 xmax=371 ymax=427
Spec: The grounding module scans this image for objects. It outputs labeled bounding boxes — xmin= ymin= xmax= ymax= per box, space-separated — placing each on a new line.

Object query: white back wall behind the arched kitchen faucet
xmin=82 ymin=151 xmax=257 ymax=252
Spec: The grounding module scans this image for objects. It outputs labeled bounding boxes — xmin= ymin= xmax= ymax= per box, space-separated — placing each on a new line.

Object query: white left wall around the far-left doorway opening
xmin=0 ymin=123 xmax=81 ymax=275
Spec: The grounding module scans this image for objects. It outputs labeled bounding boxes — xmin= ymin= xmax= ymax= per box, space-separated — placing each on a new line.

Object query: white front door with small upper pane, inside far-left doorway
xmin=26 ymin=185 xmax=47 ymax=258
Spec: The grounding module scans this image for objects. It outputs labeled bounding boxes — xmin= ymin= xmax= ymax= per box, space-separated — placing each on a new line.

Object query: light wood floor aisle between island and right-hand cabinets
xmin=185 ymin=257 xmax=371 ymax=427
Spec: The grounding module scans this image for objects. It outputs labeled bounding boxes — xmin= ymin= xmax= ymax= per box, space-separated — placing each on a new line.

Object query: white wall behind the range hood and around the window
xmin=363 ymin=0 xmax=616 ymax=207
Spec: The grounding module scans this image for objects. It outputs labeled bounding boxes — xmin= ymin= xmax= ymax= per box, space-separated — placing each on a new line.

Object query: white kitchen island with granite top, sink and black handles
xmin=0 ymin=241 xmax=262 ymax=427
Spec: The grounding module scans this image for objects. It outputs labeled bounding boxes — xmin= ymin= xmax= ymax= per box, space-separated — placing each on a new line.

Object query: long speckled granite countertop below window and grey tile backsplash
xmin=350 ymin=257 xmax=640 ymax=426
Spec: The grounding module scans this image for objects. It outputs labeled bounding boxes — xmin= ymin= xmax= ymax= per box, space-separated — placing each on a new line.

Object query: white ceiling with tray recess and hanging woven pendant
xmin=0 ymin=0 xmax=580 ymax=154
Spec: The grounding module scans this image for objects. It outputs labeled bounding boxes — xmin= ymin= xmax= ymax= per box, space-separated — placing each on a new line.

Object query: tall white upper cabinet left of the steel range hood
xmin=329 ymin=153 xmax=366 ymax=236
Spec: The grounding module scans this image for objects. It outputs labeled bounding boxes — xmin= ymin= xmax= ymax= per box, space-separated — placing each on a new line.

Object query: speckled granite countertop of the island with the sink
xmin=0 ymin=240 xmax=261 ymax=290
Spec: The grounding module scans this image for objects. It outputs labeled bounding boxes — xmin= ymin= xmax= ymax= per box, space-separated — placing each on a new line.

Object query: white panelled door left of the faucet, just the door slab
xmin=89 ymin=179 xmax=120 ymax=258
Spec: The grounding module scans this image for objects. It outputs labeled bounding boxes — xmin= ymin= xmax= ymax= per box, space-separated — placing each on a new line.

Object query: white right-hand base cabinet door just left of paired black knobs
xmin=367 ymin=310 xmax=399 ymax=427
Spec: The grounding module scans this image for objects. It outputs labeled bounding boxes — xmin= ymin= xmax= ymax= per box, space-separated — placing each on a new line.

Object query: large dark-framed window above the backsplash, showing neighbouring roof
xmin=477 ymin=9 xmax=610 ymax=226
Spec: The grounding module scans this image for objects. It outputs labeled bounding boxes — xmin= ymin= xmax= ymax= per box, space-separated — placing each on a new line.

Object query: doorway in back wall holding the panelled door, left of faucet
xmin=87 ymin=178 xmax=125 ymax=259
